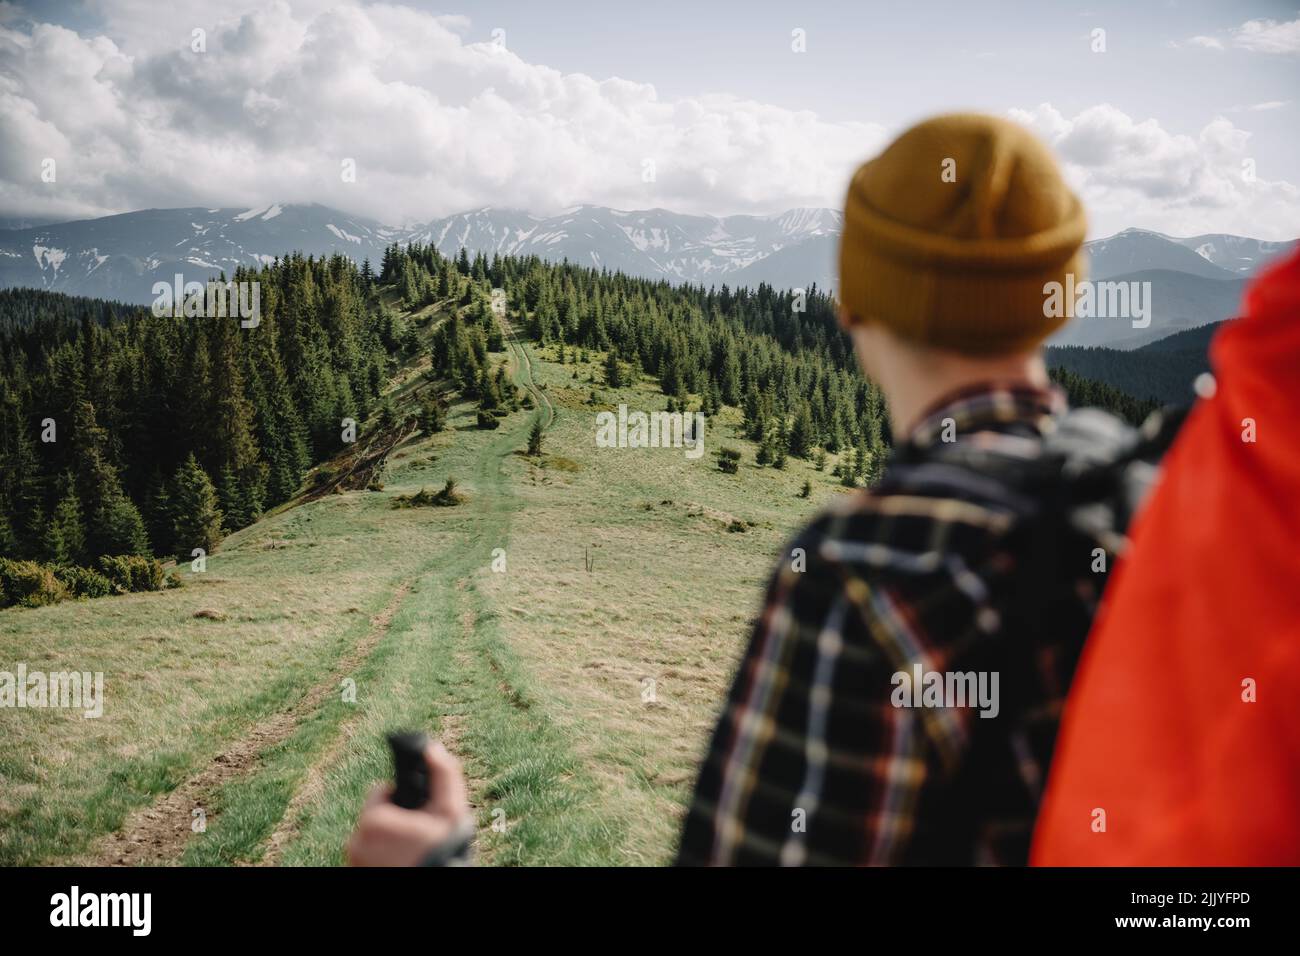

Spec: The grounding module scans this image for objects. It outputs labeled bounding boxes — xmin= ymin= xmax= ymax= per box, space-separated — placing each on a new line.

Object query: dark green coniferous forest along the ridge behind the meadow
xmin=0 ymin=245 xmax=1151 ymax=604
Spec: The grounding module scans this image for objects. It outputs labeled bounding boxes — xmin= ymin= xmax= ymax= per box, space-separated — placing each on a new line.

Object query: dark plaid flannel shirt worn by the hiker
xmin=679 ymin=385 xmax=1105 ymax=865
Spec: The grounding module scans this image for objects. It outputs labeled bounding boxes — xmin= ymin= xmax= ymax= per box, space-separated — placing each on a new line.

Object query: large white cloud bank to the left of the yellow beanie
xmin=0 ymin=3 xmax=884 ymax=221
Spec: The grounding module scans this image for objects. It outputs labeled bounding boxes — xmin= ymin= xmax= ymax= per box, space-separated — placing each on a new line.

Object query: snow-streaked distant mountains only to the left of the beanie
xmin=0 ymin=203 xmax=840 ymax=302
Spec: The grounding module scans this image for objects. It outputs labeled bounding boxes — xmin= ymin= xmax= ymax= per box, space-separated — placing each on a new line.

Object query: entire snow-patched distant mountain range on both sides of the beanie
xmin=0 ymin=203 xmax=1290 ymax=349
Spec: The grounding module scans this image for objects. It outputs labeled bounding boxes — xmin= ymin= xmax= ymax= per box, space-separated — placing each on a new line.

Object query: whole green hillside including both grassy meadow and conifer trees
xmin=0 ymin=247 xmax=1170 ymax=865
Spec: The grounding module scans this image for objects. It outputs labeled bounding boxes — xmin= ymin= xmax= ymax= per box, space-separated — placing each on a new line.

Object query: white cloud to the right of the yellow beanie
xmin=1010 ymin=103 xmax=1300 ymax=239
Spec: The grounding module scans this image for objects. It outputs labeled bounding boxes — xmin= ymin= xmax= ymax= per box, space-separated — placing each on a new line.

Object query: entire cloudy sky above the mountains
xmin=0 ymin=0 xmax=1300 ymax=239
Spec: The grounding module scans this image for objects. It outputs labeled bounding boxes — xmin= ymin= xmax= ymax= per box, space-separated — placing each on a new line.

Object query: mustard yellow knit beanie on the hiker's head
xmin=840 ymin=113 xmax=1087 ymax=355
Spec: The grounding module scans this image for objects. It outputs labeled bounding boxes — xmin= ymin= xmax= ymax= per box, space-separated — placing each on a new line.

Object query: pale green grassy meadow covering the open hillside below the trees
xmin=0 ymin=299 xmax=863 ymax=865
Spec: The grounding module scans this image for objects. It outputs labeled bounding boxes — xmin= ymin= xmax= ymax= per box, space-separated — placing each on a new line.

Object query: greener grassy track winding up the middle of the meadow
xmin=169 ymin=328 xmax=618 ymax=865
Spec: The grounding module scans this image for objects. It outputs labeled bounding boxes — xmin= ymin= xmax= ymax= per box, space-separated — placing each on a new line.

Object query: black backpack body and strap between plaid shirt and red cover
xmin=874 ymin=408 xmax=1183 ymax=862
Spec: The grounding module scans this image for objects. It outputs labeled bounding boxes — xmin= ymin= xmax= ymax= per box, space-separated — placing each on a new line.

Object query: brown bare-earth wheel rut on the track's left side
xmin=82 ymin=583 xmax=411 ymax=866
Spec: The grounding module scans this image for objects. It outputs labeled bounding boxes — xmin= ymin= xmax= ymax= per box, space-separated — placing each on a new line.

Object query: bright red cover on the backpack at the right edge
xmin=1031 ymin=247 xmax=1300 ymax=866
